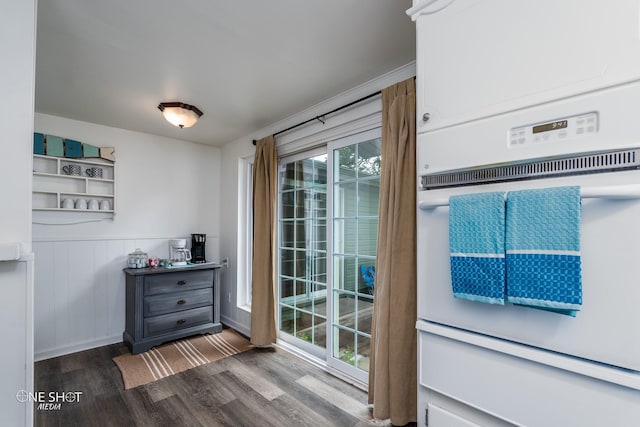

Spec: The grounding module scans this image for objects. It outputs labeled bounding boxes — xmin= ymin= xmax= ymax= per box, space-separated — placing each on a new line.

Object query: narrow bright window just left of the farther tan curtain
xmin=236 ymin=156 xmax=253 ymax=313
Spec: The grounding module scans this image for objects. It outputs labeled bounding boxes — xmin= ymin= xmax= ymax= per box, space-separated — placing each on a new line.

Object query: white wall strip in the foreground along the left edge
xmin=0 ymin=0 xmax=36 ymax=426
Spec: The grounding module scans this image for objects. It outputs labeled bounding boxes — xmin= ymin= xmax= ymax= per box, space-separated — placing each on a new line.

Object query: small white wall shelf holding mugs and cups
xmin=32 ymin=154 xmax=116 ymax=224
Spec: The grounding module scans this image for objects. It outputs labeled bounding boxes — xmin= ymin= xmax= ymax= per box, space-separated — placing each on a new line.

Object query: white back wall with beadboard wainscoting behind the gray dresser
xmin=33 ymin=113 xmax=221 ymax=360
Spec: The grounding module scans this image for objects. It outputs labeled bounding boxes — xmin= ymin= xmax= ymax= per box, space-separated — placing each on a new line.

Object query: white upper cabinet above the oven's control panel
xmin=407 ymin=0 xmax=640 ymax=133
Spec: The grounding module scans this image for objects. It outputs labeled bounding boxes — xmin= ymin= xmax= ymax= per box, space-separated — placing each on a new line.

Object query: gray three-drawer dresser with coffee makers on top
xmin=122 ymin=264 xmax=222 ymax=354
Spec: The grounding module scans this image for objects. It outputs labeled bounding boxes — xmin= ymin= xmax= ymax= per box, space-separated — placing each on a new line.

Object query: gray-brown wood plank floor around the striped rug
xmin=34 ymin=338 xmax=410 ymax=427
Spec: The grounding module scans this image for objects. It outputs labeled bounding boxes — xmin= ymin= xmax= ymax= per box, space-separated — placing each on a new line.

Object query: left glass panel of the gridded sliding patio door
xmin=278 ymin=149 xmax=327 ymax=357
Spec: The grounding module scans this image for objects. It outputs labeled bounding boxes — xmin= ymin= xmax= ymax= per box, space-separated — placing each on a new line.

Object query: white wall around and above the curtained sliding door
xmin=220 ymin=63 xmax=415 ymax=335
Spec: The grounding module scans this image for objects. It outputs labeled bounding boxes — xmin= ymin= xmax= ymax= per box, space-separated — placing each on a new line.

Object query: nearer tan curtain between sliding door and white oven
xmin=369 ymin=78 xmax=417 ymax=425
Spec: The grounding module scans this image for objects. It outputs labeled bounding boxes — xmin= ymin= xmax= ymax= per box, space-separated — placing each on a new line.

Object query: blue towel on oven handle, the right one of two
xmin=506 ymin=187 xmax=582 ymax=316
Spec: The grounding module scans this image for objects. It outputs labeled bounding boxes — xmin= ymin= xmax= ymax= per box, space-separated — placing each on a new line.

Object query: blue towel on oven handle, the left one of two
xmin=449 ymin=192 xmax=505 ymax=304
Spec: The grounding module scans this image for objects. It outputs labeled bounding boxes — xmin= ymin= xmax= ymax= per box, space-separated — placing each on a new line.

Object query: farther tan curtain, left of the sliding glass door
xmin=251 ymin=136 xmax=278 ymax=345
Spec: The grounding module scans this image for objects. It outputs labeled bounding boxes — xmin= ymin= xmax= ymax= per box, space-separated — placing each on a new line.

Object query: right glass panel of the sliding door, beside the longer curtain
xmin=328 ymin=129 xmax=381 ymax=382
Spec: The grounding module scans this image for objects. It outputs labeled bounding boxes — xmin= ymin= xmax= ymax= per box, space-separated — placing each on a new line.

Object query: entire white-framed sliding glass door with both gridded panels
xmin=278 ymin=129 xmax=381 ymax=382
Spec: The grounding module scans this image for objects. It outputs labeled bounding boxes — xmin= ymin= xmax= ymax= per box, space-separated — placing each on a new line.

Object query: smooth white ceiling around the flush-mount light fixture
xmin=35 ymin=0 xmax=415 ymax=146
